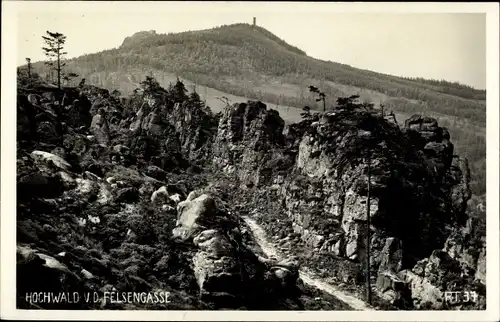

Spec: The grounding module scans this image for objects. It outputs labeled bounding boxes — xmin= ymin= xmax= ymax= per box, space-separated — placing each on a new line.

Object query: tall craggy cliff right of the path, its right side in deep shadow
xmin=212 ymin=102 xmax=482 ymax=308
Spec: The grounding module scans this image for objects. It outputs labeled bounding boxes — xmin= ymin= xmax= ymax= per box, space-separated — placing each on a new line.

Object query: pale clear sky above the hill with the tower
xmin=17 ymin=1 xmax=486 ymax=89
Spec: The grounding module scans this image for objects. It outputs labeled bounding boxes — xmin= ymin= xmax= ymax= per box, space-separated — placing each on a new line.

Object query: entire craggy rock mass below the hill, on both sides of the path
xmin=17 ymin=78 xmax=485 ymax=309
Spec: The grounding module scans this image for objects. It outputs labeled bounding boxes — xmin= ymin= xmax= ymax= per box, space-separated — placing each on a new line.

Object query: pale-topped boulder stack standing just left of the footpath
xmin=173 ymin=191 xmax=298 ymax=308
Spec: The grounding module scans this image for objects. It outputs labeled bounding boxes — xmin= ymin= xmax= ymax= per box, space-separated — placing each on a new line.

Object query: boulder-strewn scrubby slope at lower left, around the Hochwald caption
xmin=17 ymin=132 xmax=213 ymax=309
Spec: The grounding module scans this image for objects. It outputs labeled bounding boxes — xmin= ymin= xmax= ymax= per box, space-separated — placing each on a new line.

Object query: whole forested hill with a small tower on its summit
xmin=26 ymin=24 xmax=486 ymax=193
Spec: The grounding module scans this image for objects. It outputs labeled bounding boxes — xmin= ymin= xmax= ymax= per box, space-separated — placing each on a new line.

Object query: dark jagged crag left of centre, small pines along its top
xmin=124 ymin=96 xmax=217 ymax=170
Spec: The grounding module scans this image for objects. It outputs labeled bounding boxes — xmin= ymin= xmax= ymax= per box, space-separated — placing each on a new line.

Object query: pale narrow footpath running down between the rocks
xmin=242 ymin=216 xmax=374 ymax=311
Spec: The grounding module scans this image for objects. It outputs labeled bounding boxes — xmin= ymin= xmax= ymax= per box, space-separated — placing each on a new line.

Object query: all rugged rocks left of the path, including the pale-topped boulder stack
xmin=17 ymin=86 xmax=312 ymax=309
